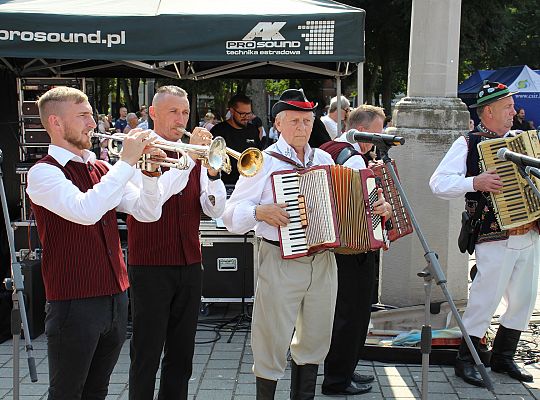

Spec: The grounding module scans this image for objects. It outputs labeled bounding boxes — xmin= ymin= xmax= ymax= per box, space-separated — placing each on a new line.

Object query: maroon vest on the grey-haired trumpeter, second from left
xmin=127 ymin=162 xmax=201 ymax=266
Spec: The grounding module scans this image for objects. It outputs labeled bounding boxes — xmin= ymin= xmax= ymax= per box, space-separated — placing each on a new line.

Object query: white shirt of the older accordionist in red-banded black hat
xmin=223 ymin=136 xmax=334 ymax=240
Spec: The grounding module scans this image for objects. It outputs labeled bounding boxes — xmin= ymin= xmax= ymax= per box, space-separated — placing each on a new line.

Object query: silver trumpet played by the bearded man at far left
xmin=90 ymin=132 xmax=227 ymax=169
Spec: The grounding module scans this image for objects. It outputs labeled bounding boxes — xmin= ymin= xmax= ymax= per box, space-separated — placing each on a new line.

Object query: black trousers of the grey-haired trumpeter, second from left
xmin=128 ymin=263 xmax=202 ymax=400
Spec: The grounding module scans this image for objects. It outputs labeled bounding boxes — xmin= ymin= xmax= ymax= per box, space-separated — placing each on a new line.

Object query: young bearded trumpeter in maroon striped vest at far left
xmin=27 ymin=87 xmax=165 ymax=400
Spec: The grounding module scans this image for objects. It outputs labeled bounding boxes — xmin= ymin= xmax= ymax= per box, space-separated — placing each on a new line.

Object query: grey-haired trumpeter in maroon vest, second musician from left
xmin=127 ymin=86 xmax=227 ymax=400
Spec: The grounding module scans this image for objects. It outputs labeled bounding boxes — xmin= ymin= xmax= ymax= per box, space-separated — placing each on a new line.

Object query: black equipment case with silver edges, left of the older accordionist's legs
xmin=201 ymin=232 xmax=257 ymax=302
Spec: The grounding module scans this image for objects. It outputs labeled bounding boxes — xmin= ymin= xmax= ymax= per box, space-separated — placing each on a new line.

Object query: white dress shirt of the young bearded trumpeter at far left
xmin=26 ymin=144 xmax=165 ymax=225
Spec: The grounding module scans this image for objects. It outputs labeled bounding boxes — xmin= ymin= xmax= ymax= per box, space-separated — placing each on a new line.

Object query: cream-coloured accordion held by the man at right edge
xmin=477 ymin=131 xmax=540 ymax=229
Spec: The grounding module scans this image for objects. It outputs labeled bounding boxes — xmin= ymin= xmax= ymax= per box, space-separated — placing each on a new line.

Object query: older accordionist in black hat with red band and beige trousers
xmin=223 ymin=89 xmax=350 ymax=400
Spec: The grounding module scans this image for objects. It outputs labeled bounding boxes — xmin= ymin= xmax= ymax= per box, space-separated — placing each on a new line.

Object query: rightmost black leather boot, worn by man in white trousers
xmin=491 ymin=325 xmax=533 ymax=382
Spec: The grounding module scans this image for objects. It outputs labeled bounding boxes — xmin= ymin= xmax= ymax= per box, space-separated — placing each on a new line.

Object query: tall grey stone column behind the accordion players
xmin=381 ymin=0 xmax=469 ymax=307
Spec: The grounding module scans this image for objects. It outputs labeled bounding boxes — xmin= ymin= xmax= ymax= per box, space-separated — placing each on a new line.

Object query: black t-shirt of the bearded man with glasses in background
xmin=210 ymin=121 xmax=261 ymax=185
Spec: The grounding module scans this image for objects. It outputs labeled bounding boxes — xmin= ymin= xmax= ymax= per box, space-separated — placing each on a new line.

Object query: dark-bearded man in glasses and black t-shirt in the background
xmin=210 ymin=94 xmax=262 ymax=185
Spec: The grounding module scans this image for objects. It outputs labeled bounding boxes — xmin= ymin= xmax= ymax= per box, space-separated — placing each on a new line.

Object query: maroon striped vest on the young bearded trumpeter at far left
xmin=31 ymin=156 xmax=129 ymax=300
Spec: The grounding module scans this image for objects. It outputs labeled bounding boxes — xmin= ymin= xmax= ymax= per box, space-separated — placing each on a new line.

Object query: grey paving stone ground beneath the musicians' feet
xmin=0 ymin=256 xmax=540 ymax=400
